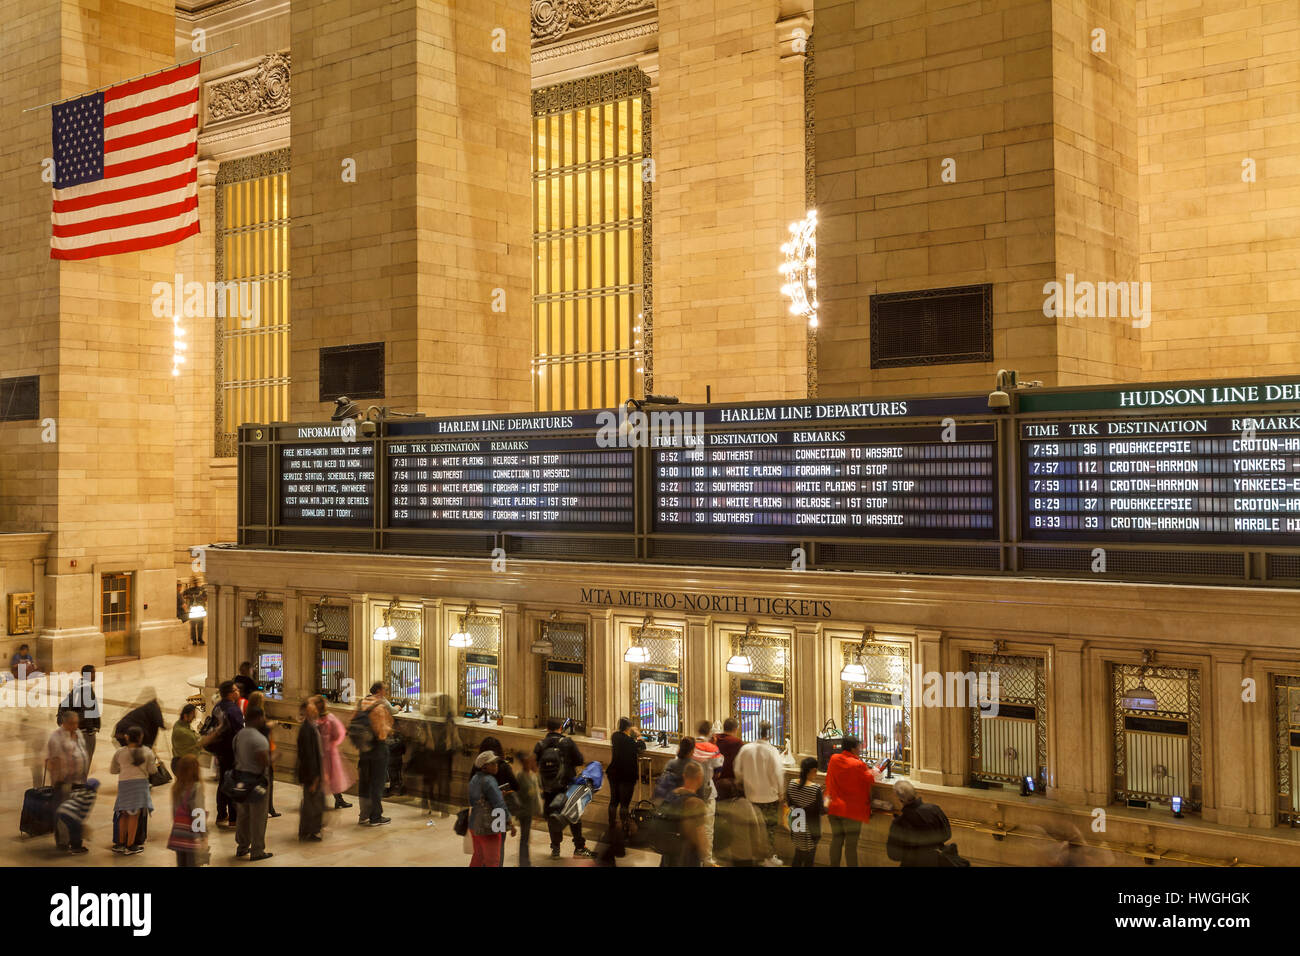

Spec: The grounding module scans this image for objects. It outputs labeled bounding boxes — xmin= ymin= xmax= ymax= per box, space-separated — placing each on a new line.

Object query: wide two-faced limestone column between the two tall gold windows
xmin=290 ymin=0 xmax=532 ymax=419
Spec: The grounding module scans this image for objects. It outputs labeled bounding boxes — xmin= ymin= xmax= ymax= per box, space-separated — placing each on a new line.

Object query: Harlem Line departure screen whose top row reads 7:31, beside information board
xmin=387 ymin=434 xmax=633 ymax=532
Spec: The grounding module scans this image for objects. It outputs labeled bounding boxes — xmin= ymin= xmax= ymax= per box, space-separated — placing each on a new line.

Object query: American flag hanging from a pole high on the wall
xmin=49 ymin=60 xmax=200 ymax=259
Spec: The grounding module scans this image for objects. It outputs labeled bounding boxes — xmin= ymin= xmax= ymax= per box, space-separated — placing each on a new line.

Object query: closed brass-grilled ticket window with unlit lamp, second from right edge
xmin=1110 ymin=663 xmax=1201 ymax=810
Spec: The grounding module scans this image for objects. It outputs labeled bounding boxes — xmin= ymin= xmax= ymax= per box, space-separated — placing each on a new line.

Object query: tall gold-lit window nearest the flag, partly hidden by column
xmin=215 ymin=150 xmax=289 ymax=457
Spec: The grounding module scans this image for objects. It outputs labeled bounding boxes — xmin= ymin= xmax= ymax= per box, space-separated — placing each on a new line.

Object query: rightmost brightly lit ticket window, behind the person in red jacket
xmin=840 ymin=640 xmax=913 ymax=774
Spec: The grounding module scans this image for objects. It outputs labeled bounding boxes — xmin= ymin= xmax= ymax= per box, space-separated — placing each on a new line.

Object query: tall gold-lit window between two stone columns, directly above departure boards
xmin=532 ymin=68 xmax=654 ymax=411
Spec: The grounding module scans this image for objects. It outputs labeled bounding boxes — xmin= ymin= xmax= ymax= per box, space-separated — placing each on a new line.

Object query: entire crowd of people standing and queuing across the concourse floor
xmin=32 ymin=662 xmax=965 ymax=868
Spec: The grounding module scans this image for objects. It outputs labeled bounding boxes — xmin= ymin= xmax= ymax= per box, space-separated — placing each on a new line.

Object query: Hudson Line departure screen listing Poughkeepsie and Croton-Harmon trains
xmin=1021 ymin=414 xmax=1300 ymax=545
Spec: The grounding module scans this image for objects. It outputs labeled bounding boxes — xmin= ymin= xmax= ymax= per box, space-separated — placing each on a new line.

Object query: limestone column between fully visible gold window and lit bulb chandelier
xmin=654 ymin=0 xmax=806 ymax=402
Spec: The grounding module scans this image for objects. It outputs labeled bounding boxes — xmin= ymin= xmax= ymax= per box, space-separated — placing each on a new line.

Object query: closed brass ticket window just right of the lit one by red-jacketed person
xmin=967 ymin=654 xmax=1048 ymax=788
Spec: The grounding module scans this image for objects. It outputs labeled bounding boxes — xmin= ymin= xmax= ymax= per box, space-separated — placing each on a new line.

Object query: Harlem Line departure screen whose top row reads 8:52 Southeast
xmin=653 ymin=423 xmax=998 ymax=538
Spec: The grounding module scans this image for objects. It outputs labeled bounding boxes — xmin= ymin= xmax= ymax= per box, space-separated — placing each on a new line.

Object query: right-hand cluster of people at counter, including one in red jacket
xmin=460 ymin=718 xmax=965 ymax=866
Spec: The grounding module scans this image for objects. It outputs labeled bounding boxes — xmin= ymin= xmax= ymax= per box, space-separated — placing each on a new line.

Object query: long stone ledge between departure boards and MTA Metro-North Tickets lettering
xmin=200 ymin=548 xmax=1300 ymax=656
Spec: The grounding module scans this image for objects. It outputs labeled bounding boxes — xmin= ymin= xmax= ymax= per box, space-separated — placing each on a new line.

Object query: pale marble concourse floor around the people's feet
xmin=0 ymin=648 xmax=659 ymax=868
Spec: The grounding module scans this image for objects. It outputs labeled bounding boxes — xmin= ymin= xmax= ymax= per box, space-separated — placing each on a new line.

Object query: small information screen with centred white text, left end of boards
xmin=280 ymin=441 xmax=374 ymax=528
